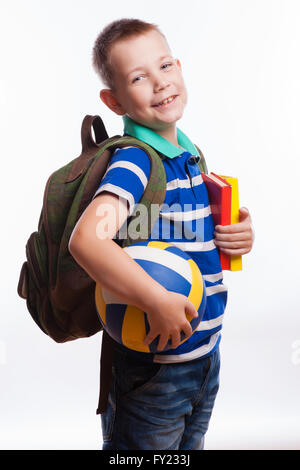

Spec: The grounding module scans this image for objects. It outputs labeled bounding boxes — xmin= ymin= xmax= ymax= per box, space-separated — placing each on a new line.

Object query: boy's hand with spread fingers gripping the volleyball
xmin=144 ymin=291 xmax=198 ymax=351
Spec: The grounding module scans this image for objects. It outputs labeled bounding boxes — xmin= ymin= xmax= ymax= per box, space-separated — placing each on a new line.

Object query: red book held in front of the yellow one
xmin=201 ymin=173 xmax=231 ymax=270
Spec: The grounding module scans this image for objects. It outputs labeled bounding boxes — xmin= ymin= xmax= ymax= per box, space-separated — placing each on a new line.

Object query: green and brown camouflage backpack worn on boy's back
xmin=18 ymin=115 xmax=206 ymax=412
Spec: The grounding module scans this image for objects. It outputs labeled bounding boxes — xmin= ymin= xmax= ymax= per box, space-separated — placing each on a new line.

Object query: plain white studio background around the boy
xmin=0 ymin=0 xmax=300 ymax=449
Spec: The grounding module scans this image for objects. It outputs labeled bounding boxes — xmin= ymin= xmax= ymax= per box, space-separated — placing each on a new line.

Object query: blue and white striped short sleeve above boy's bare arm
xmin=94 ymin=147 xmax=151 ymax=216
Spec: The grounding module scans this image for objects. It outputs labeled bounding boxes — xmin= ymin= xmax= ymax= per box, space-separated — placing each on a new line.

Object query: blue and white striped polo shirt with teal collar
xmin=94 ymin=116 xmax=227 ymax=363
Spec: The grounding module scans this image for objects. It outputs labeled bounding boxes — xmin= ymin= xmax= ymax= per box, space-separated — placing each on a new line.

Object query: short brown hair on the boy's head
xmin=93 ymin=18 xmax=165 ymax=90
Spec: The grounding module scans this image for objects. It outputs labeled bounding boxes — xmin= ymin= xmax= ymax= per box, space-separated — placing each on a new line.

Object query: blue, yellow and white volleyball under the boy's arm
xmin=95 ymin=241 xmax=206 ymax=353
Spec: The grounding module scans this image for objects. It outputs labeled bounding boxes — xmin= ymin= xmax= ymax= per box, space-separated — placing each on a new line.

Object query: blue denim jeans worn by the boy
xmin=101 ymin=348 xmax=220 ymax=450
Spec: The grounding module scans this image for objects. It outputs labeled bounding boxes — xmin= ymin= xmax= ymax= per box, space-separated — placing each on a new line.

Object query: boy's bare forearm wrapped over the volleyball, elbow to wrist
xmin=69 ymin=233 xmax=166 ymax=311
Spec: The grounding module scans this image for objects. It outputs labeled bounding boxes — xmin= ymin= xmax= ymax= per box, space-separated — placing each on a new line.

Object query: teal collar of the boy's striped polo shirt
xmin=123 ymin=116 xmax=199 ymax=158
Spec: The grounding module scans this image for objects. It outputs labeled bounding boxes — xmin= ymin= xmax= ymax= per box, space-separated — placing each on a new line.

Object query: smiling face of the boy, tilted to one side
xmin=103 ymin=31 xmax=187 ymax=131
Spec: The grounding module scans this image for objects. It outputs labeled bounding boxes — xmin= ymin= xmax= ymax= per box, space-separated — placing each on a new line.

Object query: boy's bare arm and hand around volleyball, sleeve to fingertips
xmin=69 ymin=192 xmax=198 ymax=350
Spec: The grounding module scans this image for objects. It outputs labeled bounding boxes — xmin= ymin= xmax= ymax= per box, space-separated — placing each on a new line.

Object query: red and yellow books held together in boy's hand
xmin=202 ymin=173 xmax=242 ymax=271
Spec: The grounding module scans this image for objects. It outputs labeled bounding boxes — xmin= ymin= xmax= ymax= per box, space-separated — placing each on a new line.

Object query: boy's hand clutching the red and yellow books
xmin=214 ymin=207 xmax=254 ymax=255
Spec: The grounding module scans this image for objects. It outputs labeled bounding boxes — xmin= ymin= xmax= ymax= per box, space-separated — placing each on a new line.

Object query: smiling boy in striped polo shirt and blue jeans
xmin=69 ymin=19 xmax=253 ymax=450
